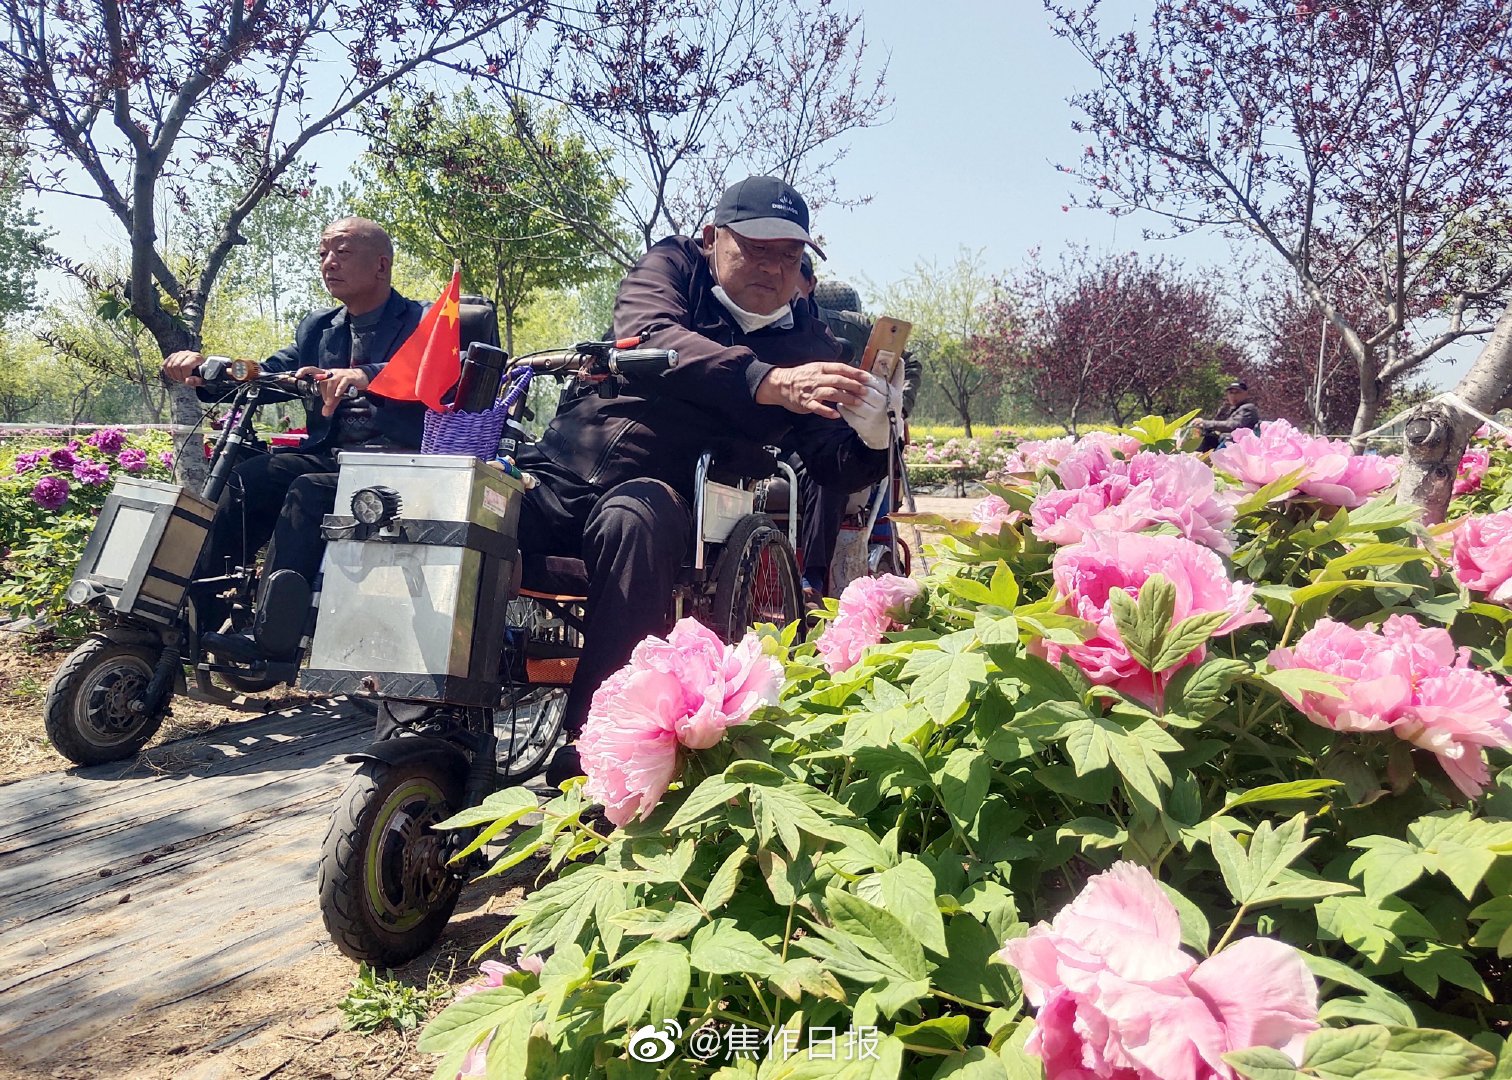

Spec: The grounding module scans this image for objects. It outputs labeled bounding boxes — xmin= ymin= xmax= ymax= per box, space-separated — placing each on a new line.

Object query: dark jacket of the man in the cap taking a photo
xmin=538 ymin=236 xmax=888 ymax=496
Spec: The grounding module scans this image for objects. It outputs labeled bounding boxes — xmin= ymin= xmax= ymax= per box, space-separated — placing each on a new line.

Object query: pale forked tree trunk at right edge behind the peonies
xmin=1391 ymin=297 xmax=1512 ymax=525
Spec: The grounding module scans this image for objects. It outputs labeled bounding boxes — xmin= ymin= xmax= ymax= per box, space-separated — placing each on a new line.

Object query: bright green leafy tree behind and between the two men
xmin=357 ymin=91 xmax=620 ymax=352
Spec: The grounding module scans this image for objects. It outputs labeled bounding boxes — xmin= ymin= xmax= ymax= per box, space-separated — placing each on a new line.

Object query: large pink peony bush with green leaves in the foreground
xmin=420 ymin=419 xmax=1512 ymax=1080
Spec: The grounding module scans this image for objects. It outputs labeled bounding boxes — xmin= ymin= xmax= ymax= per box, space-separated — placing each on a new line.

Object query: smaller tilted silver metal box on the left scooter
xmin=67 ymin=476 xmax=215 ymax=625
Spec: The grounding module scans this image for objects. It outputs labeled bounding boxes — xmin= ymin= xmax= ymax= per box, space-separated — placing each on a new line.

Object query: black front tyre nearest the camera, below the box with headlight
xmin=316 ymin=761 xmax=463 ymax=968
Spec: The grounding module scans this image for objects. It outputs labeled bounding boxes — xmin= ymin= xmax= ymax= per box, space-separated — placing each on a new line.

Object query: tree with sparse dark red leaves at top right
xmin=1045 ymin=0 xmax=1512 ymax=434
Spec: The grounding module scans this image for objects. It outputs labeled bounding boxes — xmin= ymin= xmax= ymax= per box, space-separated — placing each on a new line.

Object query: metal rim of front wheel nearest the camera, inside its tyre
xmin=366 ymin=776 xmax=455 ymax=933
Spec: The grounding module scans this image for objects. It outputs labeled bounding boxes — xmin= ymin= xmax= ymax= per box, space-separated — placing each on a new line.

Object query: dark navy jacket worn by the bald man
xmin=263 ymin=292 xmax=425 ymax=451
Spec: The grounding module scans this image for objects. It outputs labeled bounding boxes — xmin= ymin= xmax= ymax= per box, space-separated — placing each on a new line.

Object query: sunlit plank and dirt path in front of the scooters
xmin=0 ymin=665 xmax=538 ymax=1080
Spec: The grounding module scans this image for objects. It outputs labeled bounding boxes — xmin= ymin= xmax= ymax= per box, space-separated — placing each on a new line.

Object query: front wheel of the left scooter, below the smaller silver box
xmin=42 ymin=634 xmax=168 ymax=765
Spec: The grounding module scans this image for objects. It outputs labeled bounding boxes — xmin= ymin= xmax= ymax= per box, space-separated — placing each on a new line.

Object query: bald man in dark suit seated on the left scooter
xmin=163 ymin=218 xmax=423 ymax=663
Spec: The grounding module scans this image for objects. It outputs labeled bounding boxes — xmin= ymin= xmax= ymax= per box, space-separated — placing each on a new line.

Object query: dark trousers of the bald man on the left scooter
xmin=200 ymin=451 xmax=337 ymax=625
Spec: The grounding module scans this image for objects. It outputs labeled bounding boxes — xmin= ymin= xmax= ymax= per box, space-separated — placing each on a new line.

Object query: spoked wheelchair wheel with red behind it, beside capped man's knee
xmin=706 ymin=514 xmax=803 ymax=641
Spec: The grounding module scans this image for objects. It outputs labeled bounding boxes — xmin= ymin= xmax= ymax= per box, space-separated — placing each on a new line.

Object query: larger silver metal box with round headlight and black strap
xmin=299 ymin=452 xmax=522 ymax=706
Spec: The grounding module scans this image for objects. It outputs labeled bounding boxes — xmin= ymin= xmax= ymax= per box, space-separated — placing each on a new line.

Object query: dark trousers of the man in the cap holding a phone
xmin=520 ymin=454 xmax=692 ymax=738
